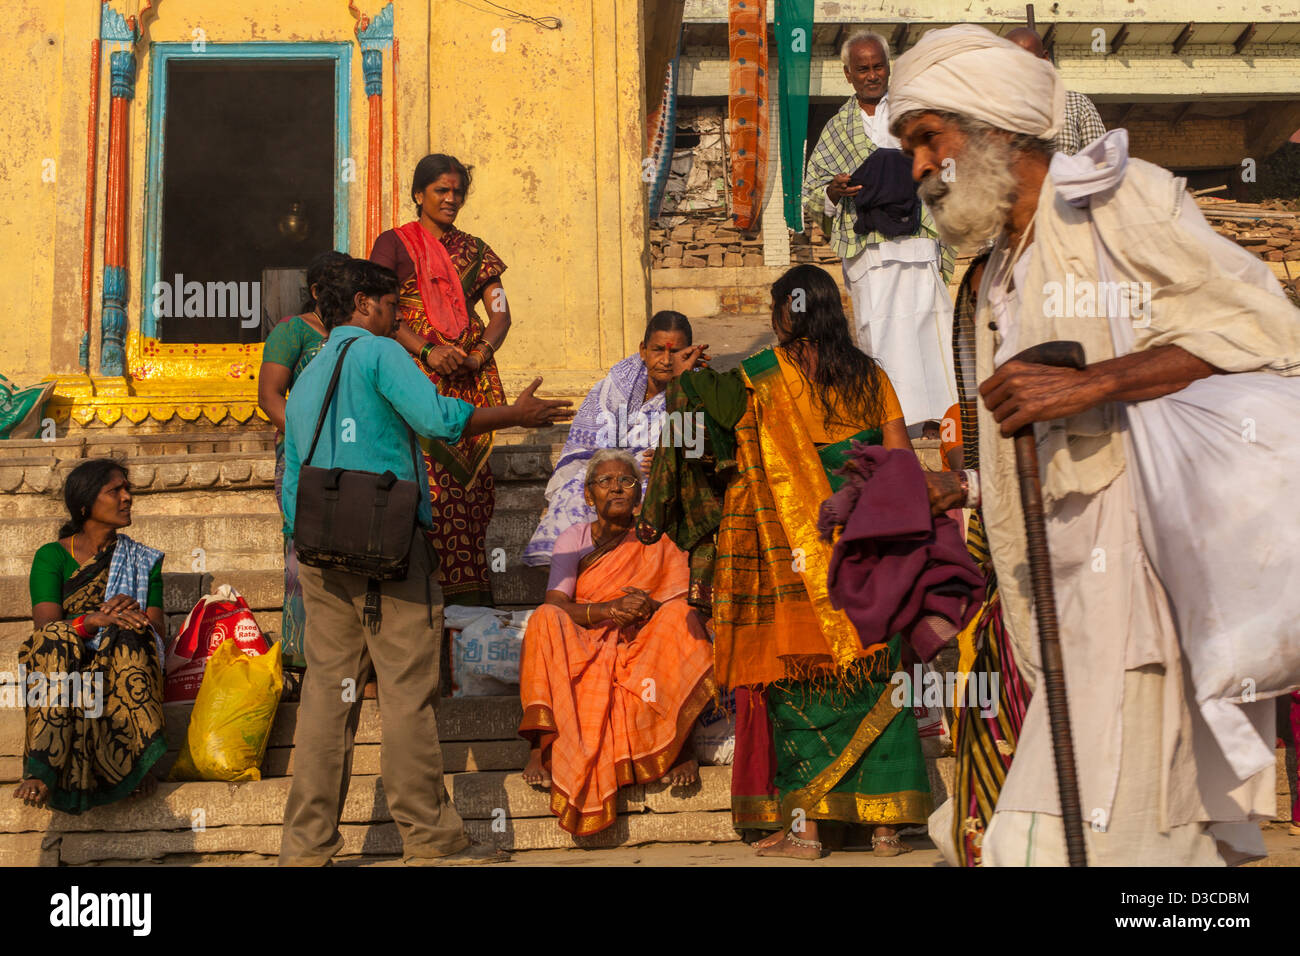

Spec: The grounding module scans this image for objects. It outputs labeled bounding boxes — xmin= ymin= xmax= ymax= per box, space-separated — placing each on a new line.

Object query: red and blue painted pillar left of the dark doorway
xmin=99 ymin=49 xmax=135 ymax=376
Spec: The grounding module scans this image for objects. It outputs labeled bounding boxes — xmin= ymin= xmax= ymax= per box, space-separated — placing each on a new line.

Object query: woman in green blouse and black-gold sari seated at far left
xmin=13 ymin=458 xmax=166 ymax=813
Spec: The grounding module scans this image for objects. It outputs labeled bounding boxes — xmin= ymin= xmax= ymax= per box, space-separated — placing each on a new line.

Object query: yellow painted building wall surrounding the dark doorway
xmin=0 ymin=0 xmax=649 ymax=408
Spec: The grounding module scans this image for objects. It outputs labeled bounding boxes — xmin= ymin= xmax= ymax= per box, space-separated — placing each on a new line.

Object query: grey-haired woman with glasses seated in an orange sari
xmin=519 ymin=449 xmax=714 ymax=835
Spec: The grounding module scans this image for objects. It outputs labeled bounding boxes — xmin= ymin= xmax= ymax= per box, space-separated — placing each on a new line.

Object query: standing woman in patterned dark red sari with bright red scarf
xmin=371 ymin=153 xmax=510 ymax=605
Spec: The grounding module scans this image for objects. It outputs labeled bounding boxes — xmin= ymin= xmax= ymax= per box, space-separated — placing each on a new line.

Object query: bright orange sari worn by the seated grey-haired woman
xmin=519 ymin=532 xmax=714 ymax=835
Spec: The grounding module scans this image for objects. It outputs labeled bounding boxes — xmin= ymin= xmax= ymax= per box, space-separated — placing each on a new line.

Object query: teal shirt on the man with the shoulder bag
xmin=281 ymin=325 xmax=475 ymax=535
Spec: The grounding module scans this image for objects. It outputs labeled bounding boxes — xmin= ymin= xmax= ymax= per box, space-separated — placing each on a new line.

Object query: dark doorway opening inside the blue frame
xmin=158 ymin=59 xmax=337 ymax=343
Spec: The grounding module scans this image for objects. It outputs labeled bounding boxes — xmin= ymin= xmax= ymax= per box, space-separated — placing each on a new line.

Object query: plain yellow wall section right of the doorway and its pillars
xmin=423 ymin=0 xmax=649 ymax=394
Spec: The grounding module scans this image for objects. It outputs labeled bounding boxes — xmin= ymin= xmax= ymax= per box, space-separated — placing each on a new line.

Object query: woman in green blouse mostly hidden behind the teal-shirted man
xmin=257 ymin=251 xmax=347 ymax=676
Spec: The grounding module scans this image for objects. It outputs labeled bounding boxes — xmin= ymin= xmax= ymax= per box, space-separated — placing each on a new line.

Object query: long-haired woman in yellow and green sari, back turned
xmin=714 ymin=265 xmax=931 ymax=860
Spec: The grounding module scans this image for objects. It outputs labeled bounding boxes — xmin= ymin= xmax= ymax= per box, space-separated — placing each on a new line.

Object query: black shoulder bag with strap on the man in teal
xmin=294 ymin=338 xmax=423 ymax=630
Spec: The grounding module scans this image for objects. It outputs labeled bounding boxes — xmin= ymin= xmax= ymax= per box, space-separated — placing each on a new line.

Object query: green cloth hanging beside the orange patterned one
xmin=775 ymin=0 xmax=813 ymax=233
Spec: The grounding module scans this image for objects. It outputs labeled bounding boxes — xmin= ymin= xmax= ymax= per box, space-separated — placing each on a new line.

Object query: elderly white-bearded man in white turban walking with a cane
xmin=892 ymin=26 xmax=1300 ymax=865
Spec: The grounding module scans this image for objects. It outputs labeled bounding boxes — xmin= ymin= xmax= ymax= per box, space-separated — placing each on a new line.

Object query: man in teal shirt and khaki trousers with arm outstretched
xmin=280 ymin=259 xmax=573 ymax=866
